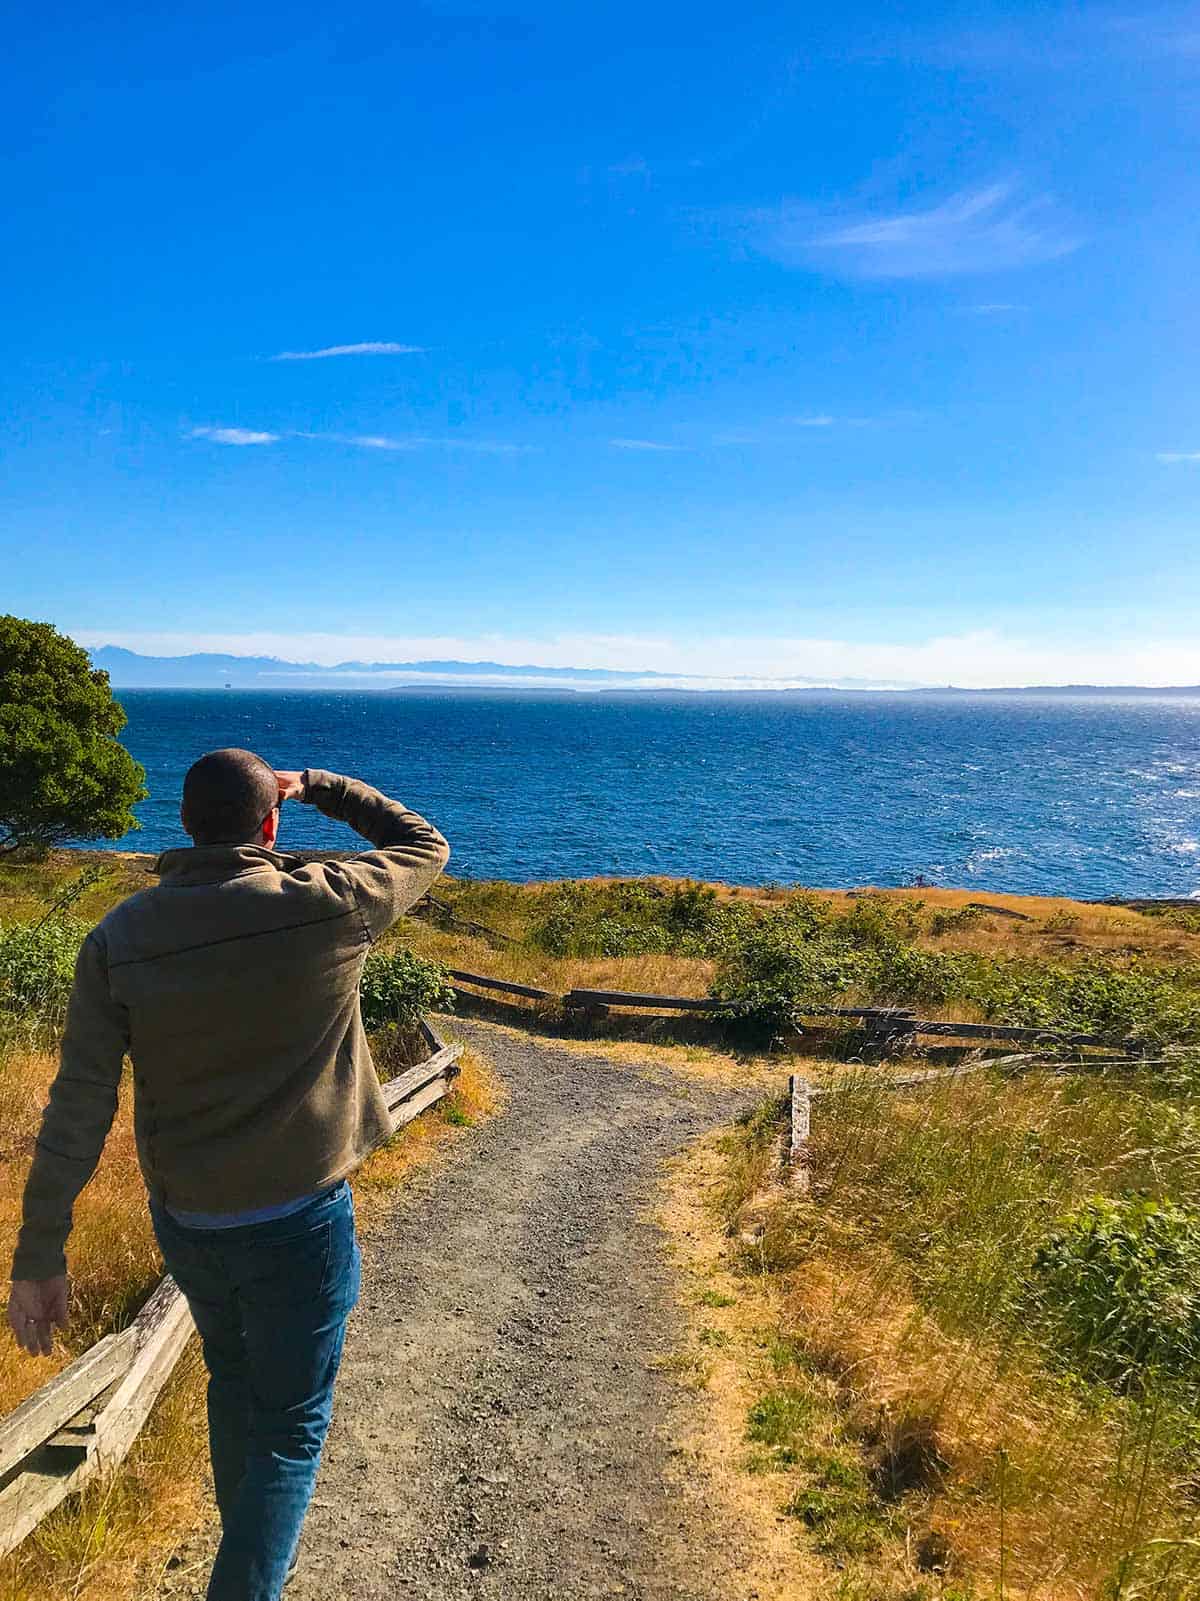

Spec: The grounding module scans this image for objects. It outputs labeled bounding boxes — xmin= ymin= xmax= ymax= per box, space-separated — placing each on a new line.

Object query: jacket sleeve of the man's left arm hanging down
xmin=13 ymin=929 xmax=130 ymax=1279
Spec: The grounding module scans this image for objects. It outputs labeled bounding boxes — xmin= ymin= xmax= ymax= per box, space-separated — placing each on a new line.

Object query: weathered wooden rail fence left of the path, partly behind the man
xmin=0 ymin=1026 xmax=462 ymax=1556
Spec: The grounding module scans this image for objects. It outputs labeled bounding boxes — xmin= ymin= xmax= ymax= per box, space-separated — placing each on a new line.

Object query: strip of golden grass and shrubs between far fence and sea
xmin=401 ymin=879 xmax=1200 ymax=1045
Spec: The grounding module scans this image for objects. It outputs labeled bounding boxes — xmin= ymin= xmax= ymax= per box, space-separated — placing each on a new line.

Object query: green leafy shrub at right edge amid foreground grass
xmin=1029 ymin=1196 xmax=1200 ymax=1386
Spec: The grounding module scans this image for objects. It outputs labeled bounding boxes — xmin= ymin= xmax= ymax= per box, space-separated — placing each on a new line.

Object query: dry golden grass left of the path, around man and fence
xmin=0 ymin=1049 xmax=499 ymax=1601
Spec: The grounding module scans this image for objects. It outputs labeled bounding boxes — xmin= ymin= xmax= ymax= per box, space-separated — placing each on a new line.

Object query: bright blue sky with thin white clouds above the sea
xmin=0 ymin=0 xmax=1200 ymax=684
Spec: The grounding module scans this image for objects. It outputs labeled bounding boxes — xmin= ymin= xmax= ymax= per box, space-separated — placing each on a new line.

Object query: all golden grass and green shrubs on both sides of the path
xmin=0 ymin=852 xmax=1200 ymax=1601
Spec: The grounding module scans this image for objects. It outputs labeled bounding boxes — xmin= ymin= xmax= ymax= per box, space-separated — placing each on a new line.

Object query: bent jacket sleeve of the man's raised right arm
xmin=302 ymin=767 xmax=450 ymax=940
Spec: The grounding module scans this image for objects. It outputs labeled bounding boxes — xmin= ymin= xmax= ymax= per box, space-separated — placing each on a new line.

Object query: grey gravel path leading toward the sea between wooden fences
xmin=160 ymin=1025 xmax=754 ymax=1601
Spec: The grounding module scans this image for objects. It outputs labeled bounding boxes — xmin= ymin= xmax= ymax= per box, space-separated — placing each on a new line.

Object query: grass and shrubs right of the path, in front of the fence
xmin=706 ymin=1052 xmax=1200 ymax=1601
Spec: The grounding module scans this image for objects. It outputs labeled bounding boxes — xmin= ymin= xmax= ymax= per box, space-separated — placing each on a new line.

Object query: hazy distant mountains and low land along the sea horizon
xmin=88 ymin=645 xmax=1200 ymax=696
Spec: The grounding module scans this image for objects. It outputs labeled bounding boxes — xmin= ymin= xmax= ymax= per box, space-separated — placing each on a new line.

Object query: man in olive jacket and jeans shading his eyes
xmin=8 ymin=749 xmax=450 ymax=1601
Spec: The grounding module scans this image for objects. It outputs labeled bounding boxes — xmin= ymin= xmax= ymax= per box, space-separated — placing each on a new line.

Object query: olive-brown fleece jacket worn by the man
xmin=13 ymin=768 xmax=450 ymax=1279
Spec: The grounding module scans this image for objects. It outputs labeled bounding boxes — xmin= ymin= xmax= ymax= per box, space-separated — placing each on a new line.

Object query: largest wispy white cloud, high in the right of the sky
xmin=754 ymin=183 xmax=1083 ymax=279
